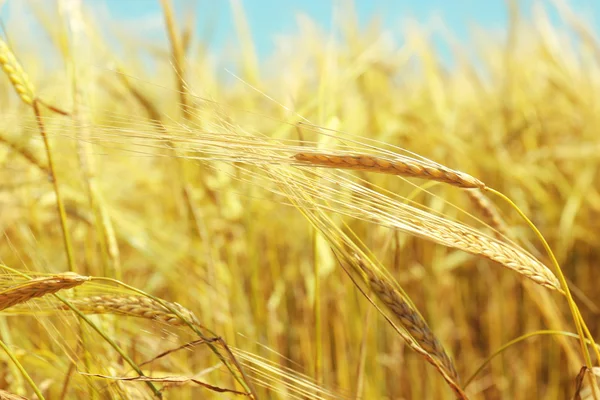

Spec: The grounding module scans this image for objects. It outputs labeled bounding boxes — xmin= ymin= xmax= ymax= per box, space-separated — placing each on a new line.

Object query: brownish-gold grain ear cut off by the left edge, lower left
xmin=0 ymin=273 xmax=90 ymax=310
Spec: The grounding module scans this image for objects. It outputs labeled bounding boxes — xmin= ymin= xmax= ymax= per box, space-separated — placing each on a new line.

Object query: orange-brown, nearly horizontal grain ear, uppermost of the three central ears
xmin=294 ymin=153 xmax=485 ymax=189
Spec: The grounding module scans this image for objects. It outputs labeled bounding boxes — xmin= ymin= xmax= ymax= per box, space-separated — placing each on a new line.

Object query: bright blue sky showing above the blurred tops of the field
xmin=0 ymin=0 xmax=600 ymax=68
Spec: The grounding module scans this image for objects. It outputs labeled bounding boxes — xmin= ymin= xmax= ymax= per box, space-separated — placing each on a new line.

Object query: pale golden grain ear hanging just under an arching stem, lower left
xmin=59 ymin=295 xmax=200 ymax=326
